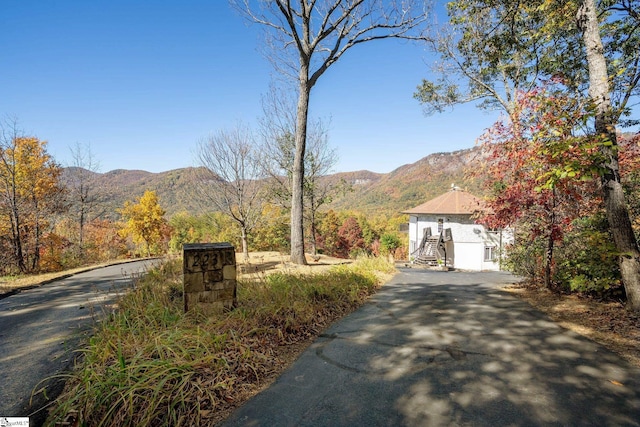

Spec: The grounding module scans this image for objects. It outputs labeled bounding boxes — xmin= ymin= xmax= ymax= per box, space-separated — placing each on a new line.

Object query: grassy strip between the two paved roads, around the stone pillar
xmin=49 ymin=258 xmax=394 ymax=426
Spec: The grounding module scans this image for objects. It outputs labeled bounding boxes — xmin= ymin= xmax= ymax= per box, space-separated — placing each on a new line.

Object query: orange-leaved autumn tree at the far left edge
xmin=0 ymin=126 xmax=62 ymax=273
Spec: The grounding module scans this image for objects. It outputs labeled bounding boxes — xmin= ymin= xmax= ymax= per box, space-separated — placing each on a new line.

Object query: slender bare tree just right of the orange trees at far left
xmin=66 ymin=143 xmax=101 ymax=251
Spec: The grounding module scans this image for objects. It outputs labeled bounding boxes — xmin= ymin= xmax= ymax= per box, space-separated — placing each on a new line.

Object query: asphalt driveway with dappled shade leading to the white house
xmin=223 ymin=269 xmax=640 ymax=427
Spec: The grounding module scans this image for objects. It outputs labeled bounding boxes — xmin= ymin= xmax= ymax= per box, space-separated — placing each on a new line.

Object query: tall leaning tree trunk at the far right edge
xmin=577 ymin=0 xmax=640 ymax=311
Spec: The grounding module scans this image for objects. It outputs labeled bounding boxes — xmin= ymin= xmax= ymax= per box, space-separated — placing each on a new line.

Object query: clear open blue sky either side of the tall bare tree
xmin=0 ymin=0 xmax=497 ymax=173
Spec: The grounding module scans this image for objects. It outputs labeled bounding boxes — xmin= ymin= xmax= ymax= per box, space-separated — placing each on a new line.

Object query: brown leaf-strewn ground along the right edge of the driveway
xmin=505 ymin=284 xmax=640 ymax=368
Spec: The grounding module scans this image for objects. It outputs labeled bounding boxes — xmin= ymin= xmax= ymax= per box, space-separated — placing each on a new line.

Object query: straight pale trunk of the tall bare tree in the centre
xmin=291 ymin=65 xmax=311 ymax=265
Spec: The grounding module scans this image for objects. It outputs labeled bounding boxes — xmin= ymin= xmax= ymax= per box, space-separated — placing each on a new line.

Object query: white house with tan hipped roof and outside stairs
xmin=403 ymin=187 xmax=513 ymax=271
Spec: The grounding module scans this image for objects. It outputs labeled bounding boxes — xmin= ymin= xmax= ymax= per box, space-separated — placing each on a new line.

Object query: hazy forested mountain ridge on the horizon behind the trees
xmin=64 ymin=148 xmax=481 ymax=219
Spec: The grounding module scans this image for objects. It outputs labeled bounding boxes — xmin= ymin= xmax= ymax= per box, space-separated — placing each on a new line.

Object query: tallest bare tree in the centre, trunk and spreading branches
xmin=230 ymin=0 xmax=427 ymax=264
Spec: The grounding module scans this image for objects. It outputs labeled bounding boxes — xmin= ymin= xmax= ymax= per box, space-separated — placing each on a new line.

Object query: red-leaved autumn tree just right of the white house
xmin=479 ymin=82 xmax=601 ymax=286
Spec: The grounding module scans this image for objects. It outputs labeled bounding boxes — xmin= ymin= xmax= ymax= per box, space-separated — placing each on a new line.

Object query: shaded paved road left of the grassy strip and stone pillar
xmin=0 ymin=261 xmax=159 ymax=424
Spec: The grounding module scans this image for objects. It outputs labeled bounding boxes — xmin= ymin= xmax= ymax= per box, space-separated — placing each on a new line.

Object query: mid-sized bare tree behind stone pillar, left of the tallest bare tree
xmin=194 ymin=125 xmax=263 ymax=259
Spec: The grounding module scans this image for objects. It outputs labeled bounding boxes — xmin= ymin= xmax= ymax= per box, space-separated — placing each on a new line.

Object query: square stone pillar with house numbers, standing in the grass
xmin=183 ymin=243 xmax=237 ymax=313
